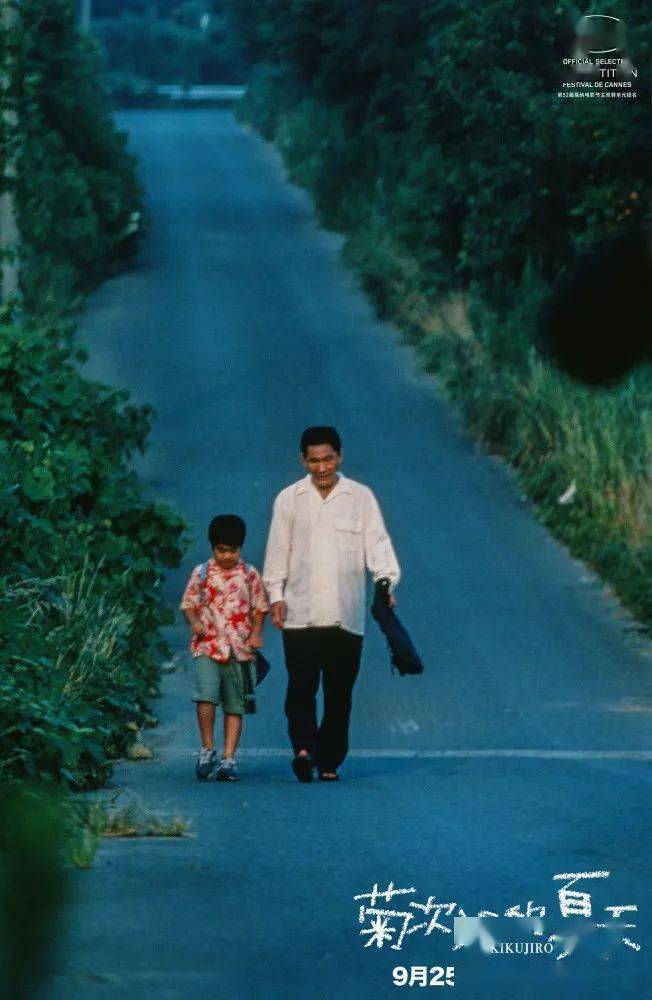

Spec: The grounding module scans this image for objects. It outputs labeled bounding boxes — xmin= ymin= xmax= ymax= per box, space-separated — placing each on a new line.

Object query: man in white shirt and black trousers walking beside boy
xmin=263 ymin=427 xmax=400 ymax=781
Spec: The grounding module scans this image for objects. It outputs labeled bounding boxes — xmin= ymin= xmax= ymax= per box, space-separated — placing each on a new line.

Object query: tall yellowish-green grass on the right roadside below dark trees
xmin=413 ymin=295 xmax=652 ymax=632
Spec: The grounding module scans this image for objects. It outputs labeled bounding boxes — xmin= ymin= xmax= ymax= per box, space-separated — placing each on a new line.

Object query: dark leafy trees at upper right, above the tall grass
xmin=235 ymin=0 xmax=652 ymax=306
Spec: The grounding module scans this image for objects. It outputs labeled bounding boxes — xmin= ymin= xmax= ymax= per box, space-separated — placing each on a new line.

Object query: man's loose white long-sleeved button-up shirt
xmin=263 ymin=475 xmax=401 ymax=635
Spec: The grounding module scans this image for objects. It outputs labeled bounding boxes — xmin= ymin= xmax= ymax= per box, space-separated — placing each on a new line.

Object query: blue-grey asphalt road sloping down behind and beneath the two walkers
xmin=46 ymin=110 xmax=652 ymax=1000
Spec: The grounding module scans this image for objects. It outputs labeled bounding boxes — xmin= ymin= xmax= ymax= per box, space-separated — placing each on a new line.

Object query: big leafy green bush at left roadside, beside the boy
xmin=0 ymin=316 xmax=183 ymax=783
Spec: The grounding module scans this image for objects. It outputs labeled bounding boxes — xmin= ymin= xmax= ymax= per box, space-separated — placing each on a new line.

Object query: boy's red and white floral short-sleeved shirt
xmin=181 ymin=557 xmax=269 ymax=663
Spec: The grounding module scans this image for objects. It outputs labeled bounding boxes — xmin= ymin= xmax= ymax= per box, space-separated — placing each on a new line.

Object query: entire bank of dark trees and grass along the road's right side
xmin=236 ymin=0 xmax=652 ymax=623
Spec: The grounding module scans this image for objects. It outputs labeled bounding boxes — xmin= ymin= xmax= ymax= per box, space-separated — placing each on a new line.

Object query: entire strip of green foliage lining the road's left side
xmin=0 ymin=0 xmax=183 ymax=787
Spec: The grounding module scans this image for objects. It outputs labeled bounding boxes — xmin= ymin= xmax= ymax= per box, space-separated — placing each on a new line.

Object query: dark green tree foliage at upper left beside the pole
xmin=13 ymin=0 xmax=142 ymax=316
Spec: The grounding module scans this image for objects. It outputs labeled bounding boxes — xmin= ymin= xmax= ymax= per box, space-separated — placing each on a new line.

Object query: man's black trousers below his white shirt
xmin=283 ymin=627 xmax=362 ymax=771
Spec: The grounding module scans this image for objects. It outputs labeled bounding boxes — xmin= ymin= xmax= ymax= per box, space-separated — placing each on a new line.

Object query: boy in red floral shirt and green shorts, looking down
xmin=181 ymin=514 xmax=269 ymax=781
